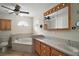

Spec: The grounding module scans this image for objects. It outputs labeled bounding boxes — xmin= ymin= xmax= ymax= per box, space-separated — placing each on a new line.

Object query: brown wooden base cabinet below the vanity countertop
xmin=33 ymin=39 xmax=67 ymax=56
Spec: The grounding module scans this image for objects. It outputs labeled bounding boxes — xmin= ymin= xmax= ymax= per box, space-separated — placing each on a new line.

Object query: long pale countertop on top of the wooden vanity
xmin=35 ymin=38 xmax=79 ymax=56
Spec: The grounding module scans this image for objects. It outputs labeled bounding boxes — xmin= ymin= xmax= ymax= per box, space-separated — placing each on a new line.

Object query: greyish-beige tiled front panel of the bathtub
xmin=12 ymin=43 xmax=32 ymax=53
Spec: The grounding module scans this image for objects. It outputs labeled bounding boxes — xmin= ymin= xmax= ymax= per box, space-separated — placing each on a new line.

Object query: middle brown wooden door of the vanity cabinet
xmin=41 ymin=43 xmax=50 ymax=56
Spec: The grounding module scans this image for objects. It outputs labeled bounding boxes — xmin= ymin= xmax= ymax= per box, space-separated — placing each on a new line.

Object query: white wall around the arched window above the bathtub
xmin=11 ymin=17 xmax=33 ymax=34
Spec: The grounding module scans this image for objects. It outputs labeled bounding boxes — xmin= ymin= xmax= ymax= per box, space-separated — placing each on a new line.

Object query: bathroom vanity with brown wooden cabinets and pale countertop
xmin=33 ymin=38 xmax=78 ymax=56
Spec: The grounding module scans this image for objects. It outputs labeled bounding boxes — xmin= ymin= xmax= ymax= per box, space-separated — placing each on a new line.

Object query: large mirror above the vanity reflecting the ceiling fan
xmin=44 ymin=3 xmax=70 ymax=30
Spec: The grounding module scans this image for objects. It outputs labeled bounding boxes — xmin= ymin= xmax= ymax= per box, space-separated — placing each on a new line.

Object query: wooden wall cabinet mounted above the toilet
xmin=0 ymin=19 xmax=11 ymax=31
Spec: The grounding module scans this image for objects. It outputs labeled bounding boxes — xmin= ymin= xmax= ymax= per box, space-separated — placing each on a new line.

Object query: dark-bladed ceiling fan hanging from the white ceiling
xmin=1 ymin=4 xmax=29 ymax=15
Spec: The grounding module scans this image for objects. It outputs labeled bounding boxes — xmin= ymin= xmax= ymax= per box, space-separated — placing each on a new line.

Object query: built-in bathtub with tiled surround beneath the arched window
xmin=12 ymin=35 xmax=32 ymax=52
